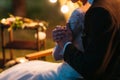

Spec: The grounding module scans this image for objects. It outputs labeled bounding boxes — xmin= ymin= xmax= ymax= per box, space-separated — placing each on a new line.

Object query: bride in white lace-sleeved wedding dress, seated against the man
xmin=0 ymin=0 xmax=92 ymax=80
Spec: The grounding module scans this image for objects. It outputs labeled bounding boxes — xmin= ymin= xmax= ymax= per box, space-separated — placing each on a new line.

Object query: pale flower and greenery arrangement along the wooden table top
xmin=0 ymin=14 xmax=48 ymax=31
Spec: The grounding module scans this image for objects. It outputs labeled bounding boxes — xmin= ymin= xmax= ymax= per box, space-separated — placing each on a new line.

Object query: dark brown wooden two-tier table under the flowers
xmin=0 ymin=23 xmax=46 ymax=64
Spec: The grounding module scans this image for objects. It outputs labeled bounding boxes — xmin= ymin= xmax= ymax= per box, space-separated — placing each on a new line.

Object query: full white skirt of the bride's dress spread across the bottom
xmin=0 ymin=60 xmax=80 ymax=80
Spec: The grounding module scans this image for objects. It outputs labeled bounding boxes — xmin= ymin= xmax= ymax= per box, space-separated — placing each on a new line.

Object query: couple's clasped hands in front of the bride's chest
xmin=52 ymin=26 xmax=72 ymax=48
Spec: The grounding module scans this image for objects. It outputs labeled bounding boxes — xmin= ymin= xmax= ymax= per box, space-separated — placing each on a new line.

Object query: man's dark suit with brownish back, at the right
xmin=64 ymin=0 xmax=120 ymax=79
